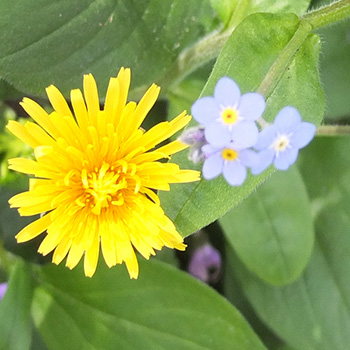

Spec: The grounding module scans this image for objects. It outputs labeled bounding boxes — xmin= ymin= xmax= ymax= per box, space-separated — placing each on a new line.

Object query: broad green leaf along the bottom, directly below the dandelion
xmin=32 ymin=261 xmax=265 ymax=350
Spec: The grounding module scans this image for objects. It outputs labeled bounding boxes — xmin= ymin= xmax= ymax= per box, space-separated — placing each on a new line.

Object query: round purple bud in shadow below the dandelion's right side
xmin=188 ymin=243 xmax=221 ymax=283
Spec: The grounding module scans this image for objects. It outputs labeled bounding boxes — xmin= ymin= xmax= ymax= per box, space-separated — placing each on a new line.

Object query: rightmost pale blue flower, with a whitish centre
xmin=252 ymin=106 xmax=316 ymax=175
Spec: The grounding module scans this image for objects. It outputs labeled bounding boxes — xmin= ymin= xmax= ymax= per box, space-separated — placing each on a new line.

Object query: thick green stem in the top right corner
xmin=301 ymin=0 xmax=350 ymax=29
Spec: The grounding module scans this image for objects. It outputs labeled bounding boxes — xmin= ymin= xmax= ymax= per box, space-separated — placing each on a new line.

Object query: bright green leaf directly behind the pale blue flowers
xmin=160 ymin=14 xmax=324 ymax=236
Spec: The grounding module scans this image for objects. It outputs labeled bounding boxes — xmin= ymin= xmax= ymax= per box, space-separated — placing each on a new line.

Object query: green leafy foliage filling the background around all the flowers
xmin=0 ymin=0 xmax=350 ymax=350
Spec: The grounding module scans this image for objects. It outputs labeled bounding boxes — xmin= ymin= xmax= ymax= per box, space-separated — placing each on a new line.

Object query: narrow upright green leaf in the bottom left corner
xmin=0 ymin=260 xmax=33 ymax=350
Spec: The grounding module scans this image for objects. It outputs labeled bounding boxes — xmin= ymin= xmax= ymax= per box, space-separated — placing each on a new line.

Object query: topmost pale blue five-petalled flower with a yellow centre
xmin=192 ymin=77 xmax=265 ymax=149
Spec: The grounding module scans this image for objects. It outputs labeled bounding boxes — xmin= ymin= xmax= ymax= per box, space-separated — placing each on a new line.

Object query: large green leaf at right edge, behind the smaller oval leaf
xmin=233 ymin=137 xmax=350 ymax=350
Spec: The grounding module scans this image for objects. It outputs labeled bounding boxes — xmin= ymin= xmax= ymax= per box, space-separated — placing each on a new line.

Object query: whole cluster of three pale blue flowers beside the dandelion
xmin=181 ymin=77 xmax=316 ymax=186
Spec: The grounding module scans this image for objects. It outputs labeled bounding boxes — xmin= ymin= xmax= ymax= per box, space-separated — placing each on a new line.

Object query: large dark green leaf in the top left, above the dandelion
xmin=0 ymin=0 xmax=215 ymax=96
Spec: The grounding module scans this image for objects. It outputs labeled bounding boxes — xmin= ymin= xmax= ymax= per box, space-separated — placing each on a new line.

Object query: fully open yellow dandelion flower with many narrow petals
xmin=7 ymin=68 xmax=199 ymax=278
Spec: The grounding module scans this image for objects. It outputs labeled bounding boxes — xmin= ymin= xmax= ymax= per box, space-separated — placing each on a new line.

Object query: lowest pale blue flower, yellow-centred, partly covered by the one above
xmin=202 ymin=143 xmax=257 ymax=186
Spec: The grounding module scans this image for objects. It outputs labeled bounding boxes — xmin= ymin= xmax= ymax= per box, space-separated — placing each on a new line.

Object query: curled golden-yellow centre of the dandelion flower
xmin=76 ymin=163 xmax=127 ymax=215
